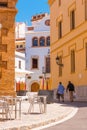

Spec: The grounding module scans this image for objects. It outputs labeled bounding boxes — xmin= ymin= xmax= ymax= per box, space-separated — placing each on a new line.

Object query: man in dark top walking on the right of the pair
xmin=66 ymin=81 xmax=75 ymax=102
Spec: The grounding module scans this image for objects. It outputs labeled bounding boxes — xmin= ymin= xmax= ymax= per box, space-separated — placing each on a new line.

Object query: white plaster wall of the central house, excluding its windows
xmin=25 ymin=12 xmax=50 ymax=91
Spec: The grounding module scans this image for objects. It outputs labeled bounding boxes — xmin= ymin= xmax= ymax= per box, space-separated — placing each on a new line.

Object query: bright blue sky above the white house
xmin=16 ymin=0 xmax=50 ymax=25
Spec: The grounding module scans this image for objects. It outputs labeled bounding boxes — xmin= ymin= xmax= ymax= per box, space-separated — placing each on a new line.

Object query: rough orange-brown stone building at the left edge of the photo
xmin=0 ymin=0 xmax=17 ymax=95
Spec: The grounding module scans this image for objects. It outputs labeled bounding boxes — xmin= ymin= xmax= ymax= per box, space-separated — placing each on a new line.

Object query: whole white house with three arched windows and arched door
xmin=25 ymin=14 xmax=50 ymax=91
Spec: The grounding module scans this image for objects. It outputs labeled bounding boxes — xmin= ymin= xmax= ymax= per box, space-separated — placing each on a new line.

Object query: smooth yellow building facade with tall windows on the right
xmin=48 ymin=0 xmax=87 ymax=100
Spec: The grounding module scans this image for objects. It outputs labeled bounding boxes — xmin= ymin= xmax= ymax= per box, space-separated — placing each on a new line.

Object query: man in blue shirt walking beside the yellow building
xmin=57 ymin=82 xmax=65 ymax=102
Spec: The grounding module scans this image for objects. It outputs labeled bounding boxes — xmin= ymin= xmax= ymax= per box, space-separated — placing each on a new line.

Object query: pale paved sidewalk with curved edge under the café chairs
xmin=0 ymin=101 xmax=76 ymax=130
